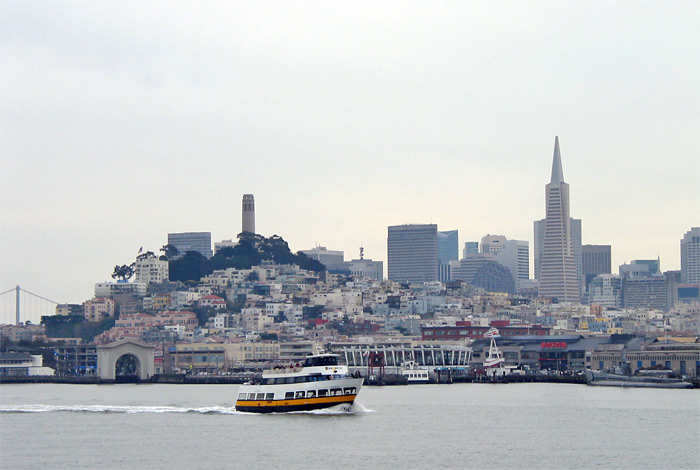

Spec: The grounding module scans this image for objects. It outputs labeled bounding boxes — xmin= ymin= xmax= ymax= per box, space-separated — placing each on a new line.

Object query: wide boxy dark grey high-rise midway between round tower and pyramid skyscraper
xmin=387 ymin=224 xmax=438 ymax=283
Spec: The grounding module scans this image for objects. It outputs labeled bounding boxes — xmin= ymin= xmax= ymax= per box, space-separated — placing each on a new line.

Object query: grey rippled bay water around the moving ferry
xmin=0 ymin=384 xmax=700 ymax=469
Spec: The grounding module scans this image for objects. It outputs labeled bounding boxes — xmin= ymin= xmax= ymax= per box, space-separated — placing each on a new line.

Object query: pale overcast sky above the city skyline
xmin=0 ymin=0 xmax=700 ymax=322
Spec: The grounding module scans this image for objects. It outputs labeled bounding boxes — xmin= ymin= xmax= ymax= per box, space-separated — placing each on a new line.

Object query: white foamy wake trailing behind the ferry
xmin=0 ymin=405 xmax=242 ymax=415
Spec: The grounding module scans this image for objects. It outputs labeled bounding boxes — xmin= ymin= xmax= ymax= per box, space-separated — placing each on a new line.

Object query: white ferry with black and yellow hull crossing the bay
xmin=236 ymin=354 xmax=364 ymax=413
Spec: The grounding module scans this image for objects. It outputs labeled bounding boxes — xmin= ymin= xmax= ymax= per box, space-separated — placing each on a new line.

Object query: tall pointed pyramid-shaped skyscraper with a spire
xmin=539 ymin=137 xmax=581 ymax=303
